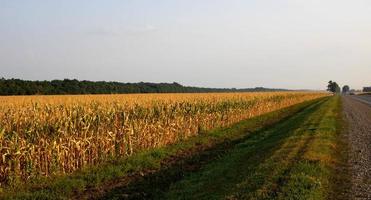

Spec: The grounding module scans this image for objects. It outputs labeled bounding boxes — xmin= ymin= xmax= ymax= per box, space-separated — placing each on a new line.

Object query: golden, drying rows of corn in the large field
xmin=0 ymin=92 xmax=326 ymax=187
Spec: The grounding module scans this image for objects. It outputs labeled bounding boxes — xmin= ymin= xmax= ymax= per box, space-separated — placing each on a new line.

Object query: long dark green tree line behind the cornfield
xmin=0 ymin=78 xmax=283 ymax=95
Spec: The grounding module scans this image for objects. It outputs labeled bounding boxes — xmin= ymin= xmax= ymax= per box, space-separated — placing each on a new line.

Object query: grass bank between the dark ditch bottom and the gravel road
xmin=164 ymin=96 xmax=346 ymax=199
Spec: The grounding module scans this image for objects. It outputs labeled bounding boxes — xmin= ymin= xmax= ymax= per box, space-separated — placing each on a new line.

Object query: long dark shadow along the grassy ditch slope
xmin=101 ymin=99 xmax=325 ymax=199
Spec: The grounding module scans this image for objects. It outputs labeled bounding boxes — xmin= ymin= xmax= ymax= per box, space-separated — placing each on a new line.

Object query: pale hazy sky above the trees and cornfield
xmin=0 ymin=0 xmax=371 ymax=89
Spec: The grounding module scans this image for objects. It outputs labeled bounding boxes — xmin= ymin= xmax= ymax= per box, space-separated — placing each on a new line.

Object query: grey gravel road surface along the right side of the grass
xmin=343 ymin=96 xmax=371 ymax=200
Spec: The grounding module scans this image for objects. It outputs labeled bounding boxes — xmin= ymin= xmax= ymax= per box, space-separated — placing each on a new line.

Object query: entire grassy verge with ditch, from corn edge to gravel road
xmin=0 ymin=97 xmax=340 ymax=199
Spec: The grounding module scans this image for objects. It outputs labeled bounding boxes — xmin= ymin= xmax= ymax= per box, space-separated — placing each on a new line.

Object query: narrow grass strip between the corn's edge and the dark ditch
xmin=0 ymin=98 xmax=324 ymax=199
